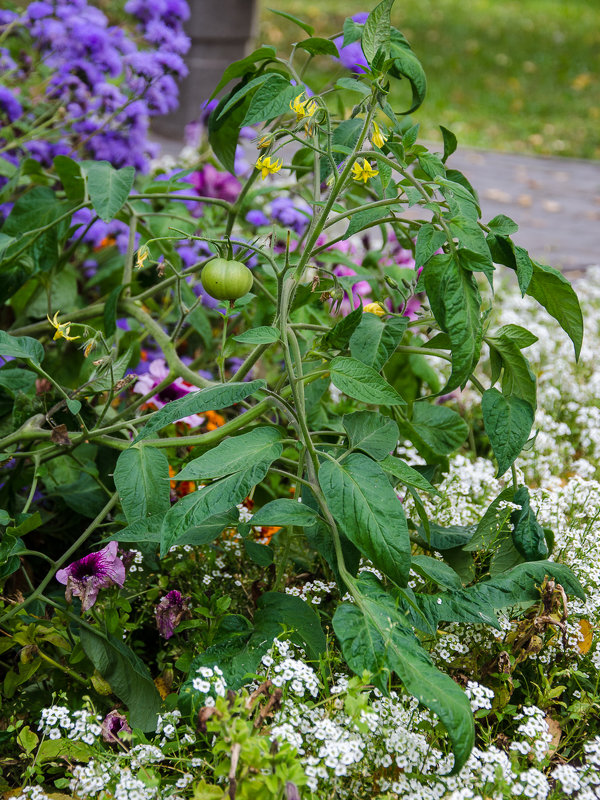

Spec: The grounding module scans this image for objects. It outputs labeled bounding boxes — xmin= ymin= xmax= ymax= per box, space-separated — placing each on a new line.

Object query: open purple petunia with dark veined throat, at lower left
xmin=56 ymin=542 xmax=125 ymax=611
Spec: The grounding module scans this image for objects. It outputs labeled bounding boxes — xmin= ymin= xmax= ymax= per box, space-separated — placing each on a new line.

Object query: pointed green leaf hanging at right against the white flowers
xmin=481 ymin=389 xmax=534 ymax=478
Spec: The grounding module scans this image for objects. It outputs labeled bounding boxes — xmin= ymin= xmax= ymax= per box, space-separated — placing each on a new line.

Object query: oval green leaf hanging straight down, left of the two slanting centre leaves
xmin=113 ymin=444 xmax=171 ymax=524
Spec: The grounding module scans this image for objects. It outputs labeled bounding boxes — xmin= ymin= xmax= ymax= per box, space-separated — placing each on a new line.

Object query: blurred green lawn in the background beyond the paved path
xmin=261 ymin=0 xmax=600 ymax=158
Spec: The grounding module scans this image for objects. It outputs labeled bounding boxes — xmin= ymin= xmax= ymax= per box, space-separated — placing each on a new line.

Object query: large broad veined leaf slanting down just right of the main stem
xmin=319 ymin=453 xmax=410 ymax=586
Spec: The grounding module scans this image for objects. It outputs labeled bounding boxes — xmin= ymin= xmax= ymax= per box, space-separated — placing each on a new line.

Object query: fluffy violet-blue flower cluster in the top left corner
xmin=0 ymin=0 xmax=190 ymax=171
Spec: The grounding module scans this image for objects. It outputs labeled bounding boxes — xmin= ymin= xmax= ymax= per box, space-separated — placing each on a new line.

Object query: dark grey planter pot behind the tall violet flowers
xmin=152 ymin=0 xmax=258 ymax=139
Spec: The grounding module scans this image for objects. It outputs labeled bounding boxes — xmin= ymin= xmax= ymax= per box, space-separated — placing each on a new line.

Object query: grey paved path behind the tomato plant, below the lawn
xmin=154 ymin=136 xmax=600 ymax=273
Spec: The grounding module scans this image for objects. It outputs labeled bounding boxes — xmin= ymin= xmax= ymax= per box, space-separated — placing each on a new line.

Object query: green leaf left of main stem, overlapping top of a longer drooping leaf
xmin=173 ymin=428 xmax=283 ymax=481
